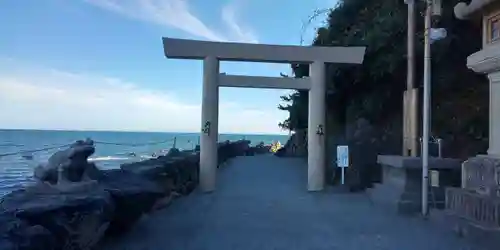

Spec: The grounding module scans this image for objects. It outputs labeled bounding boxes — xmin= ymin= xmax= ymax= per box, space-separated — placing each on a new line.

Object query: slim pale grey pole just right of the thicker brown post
xmin=422 ymin=0 xmax=432 ymax=217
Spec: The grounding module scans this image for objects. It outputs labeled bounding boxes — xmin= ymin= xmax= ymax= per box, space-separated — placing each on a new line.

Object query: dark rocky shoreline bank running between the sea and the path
xmin=0 ymin=140 xmax=269 ymax=250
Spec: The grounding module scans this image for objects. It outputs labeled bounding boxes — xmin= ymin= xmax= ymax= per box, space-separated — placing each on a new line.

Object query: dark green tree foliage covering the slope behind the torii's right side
xmin=279 ymin=0 xmax=488 ymax=156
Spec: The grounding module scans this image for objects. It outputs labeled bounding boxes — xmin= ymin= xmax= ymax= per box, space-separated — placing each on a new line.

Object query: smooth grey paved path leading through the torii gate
xmin=103 ymin=155 xmax=484 ymax=250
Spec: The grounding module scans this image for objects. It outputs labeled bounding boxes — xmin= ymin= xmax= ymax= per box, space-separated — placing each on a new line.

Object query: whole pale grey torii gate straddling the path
xmin=163 ymin=37 xmax=366 ymax=192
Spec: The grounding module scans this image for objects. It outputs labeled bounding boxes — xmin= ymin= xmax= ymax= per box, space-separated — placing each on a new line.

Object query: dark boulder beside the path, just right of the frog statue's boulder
xmin=90 ymin=169 xmax=165 ymax=235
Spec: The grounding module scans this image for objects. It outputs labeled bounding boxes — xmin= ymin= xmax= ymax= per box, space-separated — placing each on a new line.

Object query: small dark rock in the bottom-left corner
xmin=0 ymin=214 xmax=57 ymax=250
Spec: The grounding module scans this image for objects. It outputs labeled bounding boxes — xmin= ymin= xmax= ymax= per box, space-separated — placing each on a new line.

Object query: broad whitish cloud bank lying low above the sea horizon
xmin=0 ymin=58 xmax=287 ymax=133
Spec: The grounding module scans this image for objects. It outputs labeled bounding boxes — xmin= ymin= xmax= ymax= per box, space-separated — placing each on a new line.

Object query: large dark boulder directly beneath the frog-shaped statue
xmin=0 ymin=182 xmax=114 ymax=249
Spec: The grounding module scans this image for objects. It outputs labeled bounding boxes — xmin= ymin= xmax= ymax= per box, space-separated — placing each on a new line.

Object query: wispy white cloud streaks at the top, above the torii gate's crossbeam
xmin=84 ymin=0 xmax=258 ymax=43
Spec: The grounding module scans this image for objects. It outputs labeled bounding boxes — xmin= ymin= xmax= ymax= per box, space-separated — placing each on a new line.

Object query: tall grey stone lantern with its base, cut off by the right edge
xmin=446 ymin=0 xmax=500 ymax=238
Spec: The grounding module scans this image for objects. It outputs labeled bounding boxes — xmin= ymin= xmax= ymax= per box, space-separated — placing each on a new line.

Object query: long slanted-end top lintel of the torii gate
xmin=163 ymin=37 xmax=366 ymax=64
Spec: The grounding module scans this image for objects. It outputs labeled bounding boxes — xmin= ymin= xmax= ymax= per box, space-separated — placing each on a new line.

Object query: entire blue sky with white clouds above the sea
xmin=0 ymin=0 xmax=335 ymax=133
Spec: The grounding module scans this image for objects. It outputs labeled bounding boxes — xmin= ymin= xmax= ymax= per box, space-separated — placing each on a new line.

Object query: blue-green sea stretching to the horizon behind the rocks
xmin=0 ymin=130 xmax=288 ymax=196
